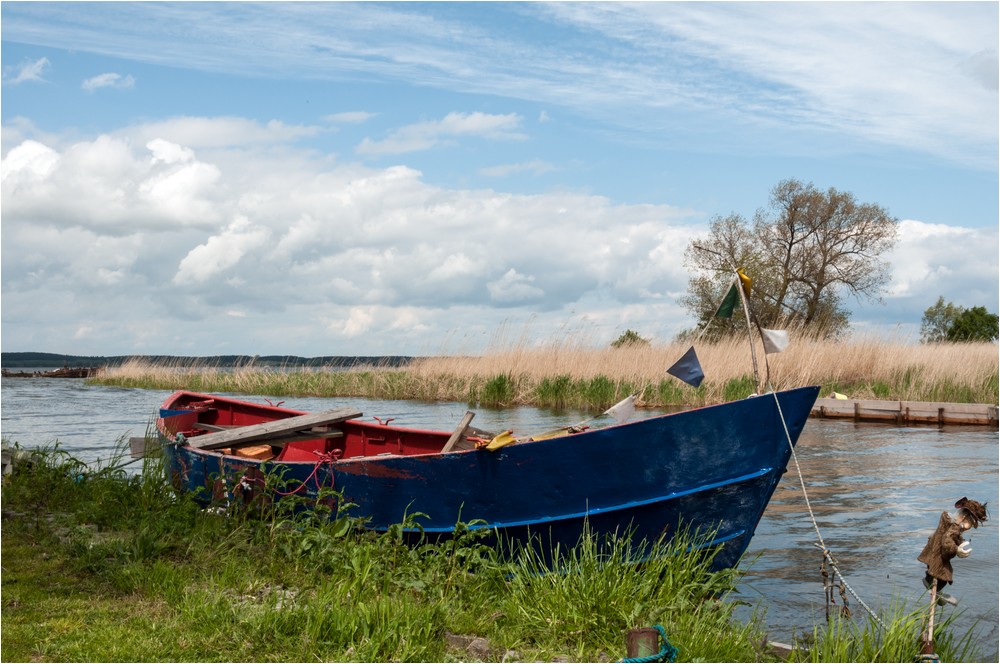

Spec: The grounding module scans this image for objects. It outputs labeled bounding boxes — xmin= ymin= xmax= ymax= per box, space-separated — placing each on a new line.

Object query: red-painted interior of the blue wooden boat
xmin=160 ymin=394 xmax=472 ymax=463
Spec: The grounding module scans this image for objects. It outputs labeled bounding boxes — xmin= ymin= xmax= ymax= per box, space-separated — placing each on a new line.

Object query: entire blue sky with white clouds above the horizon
xmin=0 ymin=2 xmax=1000 ymax=357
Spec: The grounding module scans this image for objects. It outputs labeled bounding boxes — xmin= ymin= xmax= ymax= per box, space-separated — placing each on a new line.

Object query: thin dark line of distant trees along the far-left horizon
xmin=0 ymin=352 xmax=414 ymax=369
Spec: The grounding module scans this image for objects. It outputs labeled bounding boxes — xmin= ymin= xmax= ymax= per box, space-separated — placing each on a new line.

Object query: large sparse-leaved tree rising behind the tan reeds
xmin=681 ymin=179 xmax=897 ymax=337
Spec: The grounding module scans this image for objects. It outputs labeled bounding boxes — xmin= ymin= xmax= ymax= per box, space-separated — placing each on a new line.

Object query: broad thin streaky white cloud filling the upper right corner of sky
xmin=544 ymin=3 xmax=998 ymax=167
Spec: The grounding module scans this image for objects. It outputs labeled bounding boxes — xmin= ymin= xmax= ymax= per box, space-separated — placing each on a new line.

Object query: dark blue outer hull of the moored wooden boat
xmin=160 ymin=387 xmax=819 ymax=568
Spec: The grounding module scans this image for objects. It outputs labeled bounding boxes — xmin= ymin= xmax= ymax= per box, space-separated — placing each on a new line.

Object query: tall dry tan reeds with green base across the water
xmin=91 ymin=340 xmax=1000 ymax=409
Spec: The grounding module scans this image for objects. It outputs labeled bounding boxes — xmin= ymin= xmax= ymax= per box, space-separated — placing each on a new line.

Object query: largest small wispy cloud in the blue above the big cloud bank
xmin=357 ymin=113 xmax=525 ymax=155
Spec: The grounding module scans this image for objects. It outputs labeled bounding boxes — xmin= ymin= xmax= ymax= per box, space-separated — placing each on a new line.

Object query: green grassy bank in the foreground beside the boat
xmin=2 ymin=450 xmax=977 ymax=662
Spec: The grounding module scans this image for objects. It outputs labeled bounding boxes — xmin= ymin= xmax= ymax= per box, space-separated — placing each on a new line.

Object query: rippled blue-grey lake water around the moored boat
xmin=0 ymin=378 xmax=1000 ymax=661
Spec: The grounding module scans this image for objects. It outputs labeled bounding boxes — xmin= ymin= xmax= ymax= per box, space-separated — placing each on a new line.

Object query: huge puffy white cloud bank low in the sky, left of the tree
xmin=2 ymin=116 xmax=704 ymax=354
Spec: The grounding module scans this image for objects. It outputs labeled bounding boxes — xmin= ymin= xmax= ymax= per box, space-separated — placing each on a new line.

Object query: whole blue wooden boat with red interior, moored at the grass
xmin=157 ymin=387 xmax=819 ymax=568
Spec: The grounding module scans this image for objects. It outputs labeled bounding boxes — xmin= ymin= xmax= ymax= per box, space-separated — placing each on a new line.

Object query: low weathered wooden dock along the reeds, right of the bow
xmin=810 ymin=399 xmax=997 ymax=426
